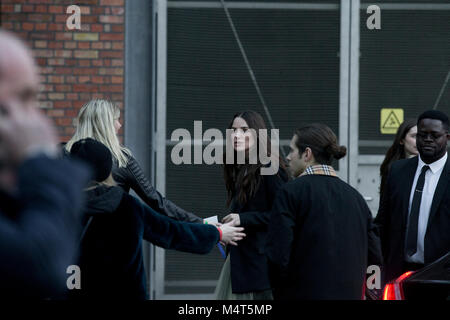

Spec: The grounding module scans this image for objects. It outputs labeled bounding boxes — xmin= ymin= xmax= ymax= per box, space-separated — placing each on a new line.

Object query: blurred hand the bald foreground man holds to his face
xmin=0 ymin=103 xmax=58 ymax=166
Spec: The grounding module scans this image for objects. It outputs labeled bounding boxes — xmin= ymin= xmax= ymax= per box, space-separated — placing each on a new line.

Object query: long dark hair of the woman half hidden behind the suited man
xmin=380 ymin=119 xmax=417 ymax=194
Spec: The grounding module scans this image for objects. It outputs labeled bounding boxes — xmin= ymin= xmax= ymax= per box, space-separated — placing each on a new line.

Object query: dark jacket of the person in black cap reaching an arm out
xmin=72 ymin=186 xmax=219 ymax=299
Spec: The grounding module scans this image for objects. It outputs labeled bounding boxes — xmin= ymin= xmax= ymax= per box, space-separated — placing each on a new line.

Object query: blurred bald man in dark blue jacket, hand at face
xmin=0 ymin=30 xmax=90 ymax=299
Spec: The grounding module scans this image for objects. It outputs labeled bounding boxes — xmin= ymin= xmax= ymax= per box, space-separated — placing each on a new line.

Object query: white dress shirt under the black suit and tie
xmin=406 ymin=152 xmax=448 ymax=263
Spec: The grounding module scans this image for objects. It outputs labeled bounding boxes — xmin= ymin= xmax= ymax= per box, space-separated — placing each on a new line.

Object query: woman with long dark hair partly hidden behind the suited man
xmin=380 ymin=119 xmax=419 ymax=199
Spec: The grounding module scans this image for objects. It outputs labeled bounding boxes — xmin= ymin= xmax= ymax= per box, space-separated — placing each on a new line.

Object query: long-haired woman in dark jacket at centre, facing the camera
xmin=216 ymin=111 xmax=288 ymax=300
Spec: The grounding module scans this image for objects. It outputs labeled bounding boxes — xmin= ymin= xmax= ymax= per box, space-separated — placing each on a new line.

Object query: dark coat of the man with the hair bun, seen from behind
xmin=267 ymin=175 xmax=381 ymax=300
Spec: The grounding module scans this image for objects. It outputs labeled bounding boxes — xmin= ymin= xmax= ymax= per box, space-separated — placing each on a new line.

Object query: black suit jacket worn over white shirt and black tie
xmin=375 ymin=157 xmax=450 ymax=281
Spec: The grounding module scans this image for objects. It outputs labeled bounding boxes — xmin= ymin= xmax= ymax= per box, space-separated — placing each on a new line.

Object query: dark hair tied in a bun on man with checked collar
xmin=294 ymin=123 xmax=347 ymax=165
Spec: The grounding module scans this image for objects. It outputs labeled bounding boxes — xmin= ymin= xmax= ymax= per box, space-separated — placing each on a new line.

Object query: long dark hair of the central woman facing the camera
xmin=223 ymin=110 xmax=286 ymax=206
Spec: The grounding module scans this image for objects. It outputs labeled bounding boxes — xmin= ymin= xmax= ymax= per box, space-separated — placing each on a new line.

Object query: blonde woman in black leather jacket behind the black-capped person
xmin=64 ymin=99 xmax=203 ymax=223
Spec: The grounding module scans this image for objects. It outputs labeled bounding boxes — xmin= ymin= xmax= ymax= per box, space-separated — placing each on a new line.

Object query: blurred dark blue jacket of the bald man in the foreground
xmin=0 ymin=156 xmax=90 ymax=299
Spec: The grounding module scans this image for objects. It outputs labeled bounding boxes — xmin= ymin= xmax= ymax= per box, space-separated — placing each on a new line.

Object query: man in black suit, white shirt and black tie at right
xmin=375 ymin=110 xmax=450 ymax=282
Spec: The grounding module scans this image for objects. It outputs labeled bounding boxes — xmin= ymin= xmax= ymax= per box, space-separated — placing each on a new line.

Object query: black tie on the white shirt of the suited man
xmin=406 ymin=166 xmax=430 ymax=257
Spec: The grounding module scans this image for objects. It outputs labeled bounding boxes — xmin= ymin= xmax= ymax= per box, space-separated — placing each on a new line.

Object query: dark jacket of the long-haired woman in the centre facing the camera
xmin=229 ymin=168 xmax=288 ymax=293
